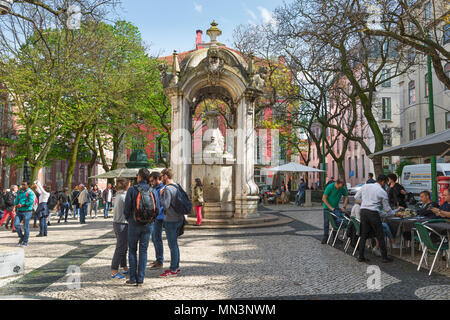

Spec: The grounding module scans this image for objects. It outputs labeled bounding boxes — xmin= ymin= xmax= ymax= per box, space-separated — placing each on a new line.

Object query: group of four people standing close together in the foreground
xmin=111 ymin=169 xmax=192 ymax=286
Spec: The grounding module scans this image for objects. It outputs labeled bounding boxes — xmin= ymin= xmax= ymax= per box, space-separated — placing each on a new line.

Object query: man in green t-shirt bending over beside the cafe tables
xmin=322 ymin=178 xmax=348 ymax=244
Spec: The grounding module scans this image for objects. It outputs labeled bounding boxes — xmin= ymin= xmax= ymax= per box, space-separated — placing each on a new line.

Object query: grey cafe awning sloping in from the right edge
xmin=369 ymin=129 xmax=450 ymax=158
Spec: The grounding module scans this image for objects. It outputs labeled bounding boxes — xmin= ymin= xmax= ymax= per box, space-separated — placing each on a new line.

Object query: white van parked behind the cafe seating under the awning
xmin=401 ymin=163 xmax=450 ymax=199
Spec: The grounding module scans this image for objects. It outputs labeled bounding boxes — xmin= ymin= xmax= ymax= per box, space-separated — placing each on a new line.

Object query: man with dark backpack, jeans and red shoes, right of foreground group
xmin=160 ymin=169 xmax=192 ymax=278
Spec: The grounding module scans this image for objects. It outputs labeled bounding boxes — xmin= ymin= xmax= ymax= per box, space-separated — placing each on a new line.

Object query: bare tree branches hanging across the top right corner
xmin=356 ymin=0 xmax=450 ymax=89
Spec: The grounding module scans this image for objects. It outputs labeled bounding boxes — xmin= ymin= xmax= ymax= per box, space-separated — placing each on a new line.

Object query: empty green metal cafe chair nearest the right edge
xmin=414 ymin=222 xmax=449 ymax=275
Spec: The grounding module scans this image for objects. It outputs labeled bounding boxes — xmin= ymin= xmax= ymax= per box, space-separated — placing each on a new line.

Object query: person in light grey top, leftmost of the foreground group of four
xmin=111 ymin=179 xmax=130 ymax=280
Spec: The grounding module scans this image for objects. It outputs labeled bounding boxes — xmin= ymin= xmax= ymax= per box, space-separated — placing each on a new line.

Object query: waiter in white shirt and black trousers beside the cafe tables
xmin=355 ymin=175 xmax=397 ymax=263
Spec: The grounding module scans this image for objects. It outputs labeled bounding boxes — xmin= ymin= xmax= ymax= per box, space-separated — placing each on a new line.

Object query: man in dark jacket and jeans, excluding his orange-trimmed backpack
xmin=124 ymin=169 xmax=160 ymax=286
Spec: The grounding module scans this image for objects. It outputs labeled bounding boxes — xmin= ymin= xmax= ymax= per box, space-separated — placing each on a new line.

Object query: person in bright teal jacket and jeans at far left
xmin=14 ymin=181 xmax=36 ymax=247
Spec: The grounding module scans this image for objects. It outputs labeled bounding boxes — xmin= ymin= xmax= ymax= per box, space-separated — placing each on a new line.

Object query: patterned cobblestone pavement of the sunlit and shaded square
xmin=0 ymin=205 xmax=450 ymax=300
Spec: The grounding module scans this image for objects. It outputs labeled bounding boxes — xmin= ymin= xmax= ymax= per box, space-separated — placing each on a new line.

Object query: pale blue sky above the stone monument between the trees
xmin=115 ymin=0 xmax=282 ymax=56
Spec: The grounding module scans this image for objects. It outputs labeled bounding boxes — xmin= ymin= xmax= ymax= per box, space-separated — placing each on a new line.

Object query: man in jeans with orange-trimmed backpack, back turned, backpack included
xmin=124 ymin=169 xmax=160 ymax=286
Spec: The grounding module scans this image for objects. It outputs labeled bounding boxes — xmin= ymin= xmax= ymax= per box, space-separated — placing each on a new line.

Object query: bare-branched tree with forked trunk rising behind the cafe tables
xmin=272 ymin=0 xmax=413 ymax=174
